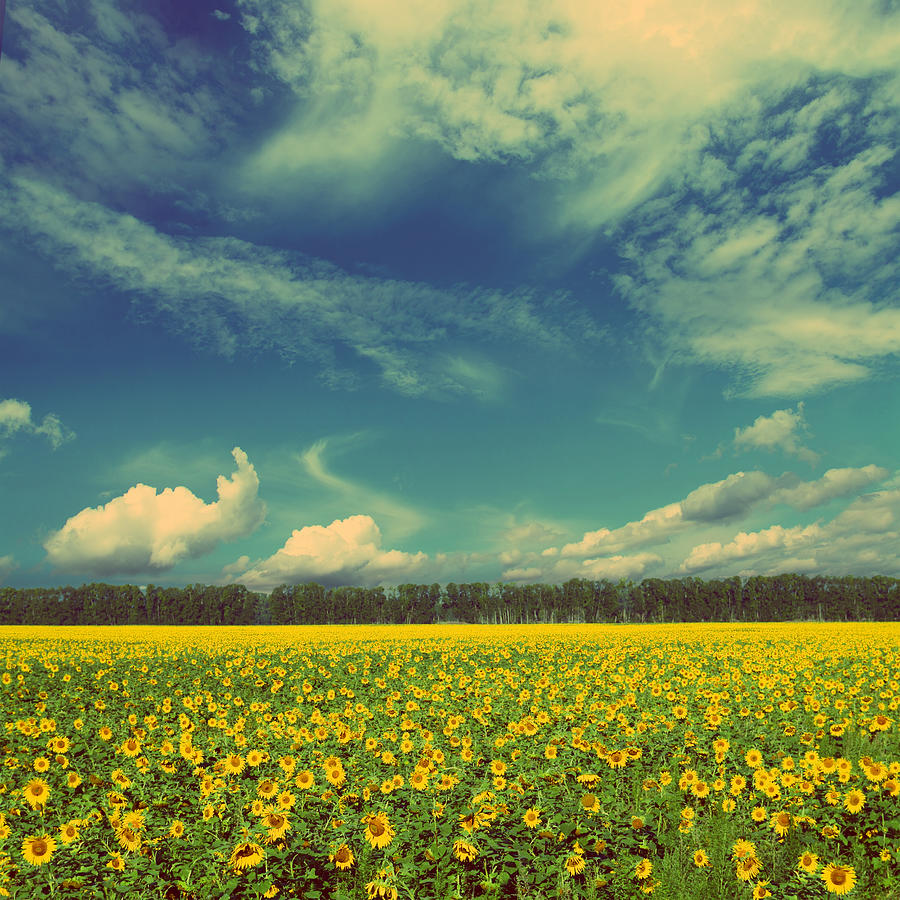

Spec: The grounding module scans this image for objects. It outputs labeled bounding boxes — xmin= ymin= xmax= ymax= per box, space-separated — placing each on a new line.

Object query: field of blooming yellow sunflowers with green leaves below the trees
xmin=0 ymin=623 xmax=900 ymax=900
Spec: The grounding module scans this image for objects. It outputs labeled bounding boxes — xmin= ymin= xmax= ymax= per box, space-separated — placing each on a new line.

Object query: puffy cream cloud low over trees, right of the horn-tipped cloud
xmin=234 ymin=515 xmax=432 ymax=590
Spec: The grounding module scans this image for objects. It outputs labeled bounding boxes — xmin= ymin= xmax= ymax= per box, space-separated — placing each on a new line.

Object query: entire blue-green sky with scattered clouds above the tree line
xmin=0 ymin=0 xmax=900 ymax=591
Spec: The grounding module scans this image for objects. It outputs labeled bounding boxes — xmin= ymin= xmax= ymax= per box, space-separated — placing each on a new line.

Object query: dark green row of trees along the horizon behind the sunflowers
xmin=0 ymin=574 xmax=900 ymax=625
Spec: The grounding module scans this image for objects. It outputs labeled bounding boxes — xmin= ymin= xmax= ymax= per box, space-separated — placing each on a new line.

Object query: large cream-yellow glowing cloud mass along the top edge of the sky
xmin=239 ymin=0 xmax=895 ymax=228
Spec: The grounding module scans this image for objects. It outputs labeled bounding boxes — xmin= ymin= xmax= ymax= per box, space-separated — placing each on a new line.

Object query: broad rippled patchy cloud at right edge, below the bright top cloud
xmin=614 ymin=72 xmax=900 ymax=398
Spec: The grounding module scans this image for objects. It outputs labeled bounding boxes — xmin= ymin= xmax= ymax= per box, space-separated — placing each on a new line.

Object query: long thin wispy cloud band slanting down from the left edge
xmin=0 ymin=176 xmax=598 ymax=396
